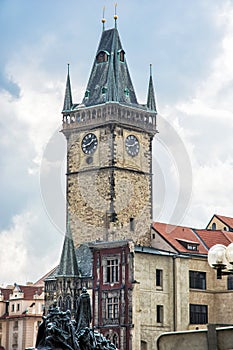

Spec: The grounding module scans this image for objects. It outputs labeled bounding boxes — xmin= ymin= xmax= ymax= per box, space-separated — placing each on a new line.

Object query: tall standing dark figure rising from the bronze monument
xmin=76 ymin=287 xmax=92 ymax=330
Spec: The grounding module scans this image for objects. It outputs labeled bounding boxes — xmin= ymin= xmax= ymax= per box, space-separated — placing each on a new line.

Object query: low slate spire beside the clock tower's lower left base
xmin=56 ymin=218 xmax=79 ymax=277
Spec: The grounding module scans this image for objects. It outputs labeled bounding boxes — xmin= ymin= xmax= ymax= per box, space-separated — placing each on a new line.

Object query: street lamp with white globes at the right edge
xmin=208 ymin=243 xmax=233 ymax=279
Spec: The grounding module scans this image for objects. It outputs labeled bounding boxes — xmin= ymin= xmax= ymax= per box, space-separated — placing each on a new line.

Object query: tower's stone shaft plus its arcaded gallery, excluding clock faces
xmin=63 ymin=103 xmax=155 ymax=246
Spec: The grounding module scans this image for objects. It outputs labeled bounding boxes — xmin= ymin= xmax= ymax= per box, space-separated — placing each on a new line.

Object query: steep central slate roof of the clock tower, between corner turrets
xmin=83 ymin=28 xmax=138 ymax=106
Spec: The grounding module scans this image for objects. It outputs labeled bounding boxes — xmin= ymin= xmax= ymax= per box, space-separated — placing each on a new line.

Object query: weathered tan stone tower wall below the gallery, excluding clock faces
xmin=67 ymin=125 xmax=152 ymax=246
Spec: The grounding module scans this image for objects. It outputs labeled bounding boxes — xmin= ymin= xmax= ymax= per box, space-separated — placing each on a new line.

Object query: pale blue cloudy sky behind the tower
xmin=0 ymin=0 xmax=233 ymax=286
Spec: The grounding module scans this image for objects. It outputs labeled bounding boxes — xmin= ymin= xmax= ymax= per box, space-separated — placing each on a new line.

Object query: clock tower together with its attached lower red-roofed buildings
xmin=45 ymin=18 xmax=233 ymax=350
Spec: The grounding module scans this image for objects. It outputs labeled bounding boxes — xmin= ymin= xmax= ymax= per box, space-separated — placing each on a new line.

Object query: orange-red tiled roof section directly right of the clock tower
xmin=152 ymin=222 xmax=207 ymax=254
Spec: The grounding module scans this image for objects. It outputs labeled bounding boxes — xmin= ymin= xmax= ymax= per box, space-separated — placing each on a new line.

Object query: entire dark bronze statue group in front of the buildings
xmin=36 ymin=288 xmax=116 ymax=350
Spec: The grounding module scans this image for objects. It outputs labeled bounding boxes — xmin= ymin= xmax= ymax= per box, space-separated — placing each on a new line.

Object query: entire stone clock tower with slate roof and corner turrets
xmin=62 ymin=18 xmax=157 ymax=246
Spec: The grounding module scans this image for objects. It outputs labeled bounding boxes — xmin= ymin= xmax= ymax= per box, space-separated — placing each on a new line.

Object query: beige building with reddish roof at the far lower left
xmin=0 ymin=284 xmax=44 ymax=350
